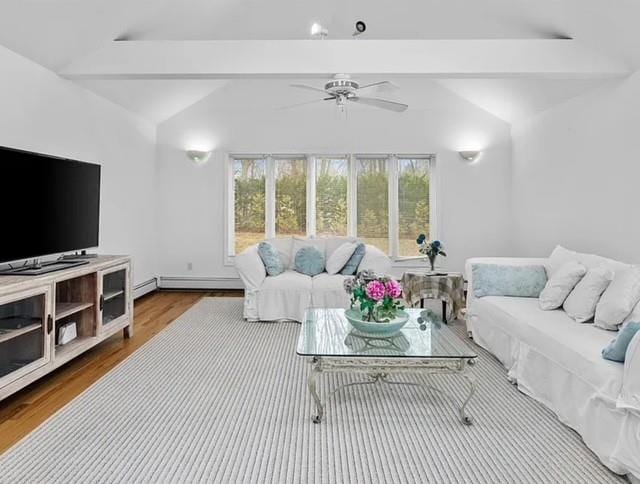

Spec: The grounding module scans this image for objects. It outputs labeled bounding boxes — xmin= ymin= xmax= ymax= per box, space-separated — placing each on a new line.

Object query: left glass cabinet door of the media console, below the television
xmin=0 ymin=288 xmax=53 ymax=387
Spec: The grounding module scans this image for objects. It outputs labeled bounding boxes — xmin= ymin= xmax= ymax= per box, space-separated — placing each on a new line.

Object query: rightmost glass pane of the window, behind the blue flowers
xmin=398 ymin=158 xmax=430 ymax=257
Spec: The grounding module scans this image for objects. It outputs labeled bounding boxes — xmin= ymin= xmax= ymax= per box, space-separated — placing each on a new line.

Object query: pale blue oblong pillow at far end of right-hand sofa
xmin=471 ymin=264 xmax=547 ymax=297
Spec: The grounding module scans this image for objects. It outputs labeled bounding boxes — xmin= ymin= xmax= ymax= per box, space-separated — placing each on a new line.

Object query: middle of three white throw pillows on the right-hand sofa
xmin=562 ymin=266 xmax=613 ymax=323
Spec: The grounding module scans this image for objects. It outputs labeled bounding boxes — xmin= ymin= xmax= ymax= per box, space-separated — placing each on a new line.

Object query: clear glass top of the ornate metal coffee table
xmin=297 ymin=308 xmax=478 ymax=359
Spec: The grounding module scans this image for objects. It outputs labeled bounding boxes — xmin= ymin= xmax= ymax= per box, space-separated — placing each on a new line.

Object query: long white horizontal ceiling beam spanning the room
xmin=60 ymin=39 xmax=629 ymax=79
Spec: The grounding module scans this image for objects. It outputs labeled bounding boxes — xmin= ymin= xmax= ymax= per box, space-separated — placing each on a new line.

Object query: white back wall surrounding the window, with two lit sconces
xmin=158 ymin=79 xmax=511 ymax=285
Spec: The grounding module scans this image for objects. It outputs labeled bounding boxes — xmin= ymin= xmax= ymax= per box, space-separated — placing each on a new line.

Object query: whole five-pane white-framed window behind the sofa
xmin=227 ymin=155 xmax=435 ymax=258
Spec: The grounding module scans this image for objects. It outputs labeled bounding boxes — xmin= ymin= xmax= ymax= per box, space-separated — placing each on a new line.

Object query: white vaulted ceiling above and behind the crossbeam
xmin=0 ymin=0 xmax=640 ymax=123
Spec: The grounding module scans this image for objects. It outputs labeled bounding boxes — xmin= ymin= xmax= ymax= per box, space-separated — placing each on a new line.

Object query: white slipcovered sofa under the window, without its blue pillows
xmin=235 ymin=236 xmax=391 ymax=322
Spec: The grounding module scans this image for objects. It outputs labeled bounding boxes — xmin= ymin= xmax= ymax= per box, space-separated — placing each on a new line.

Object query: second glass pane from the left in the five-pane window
xmin=275 ymin=158 xmax=307 ymax=236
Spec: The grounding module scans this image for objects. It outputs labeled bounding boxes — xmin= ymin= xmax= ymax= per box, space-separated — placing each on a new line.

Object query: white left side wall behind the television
xmin=0 ymin=47 xmax=156 ymax=284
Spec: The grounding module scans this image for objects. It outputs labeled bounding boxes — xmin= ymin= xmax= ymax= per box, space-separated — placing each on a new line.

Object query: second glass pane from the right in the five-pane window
xmin=356 ymin=158 xmax=389 ymax=253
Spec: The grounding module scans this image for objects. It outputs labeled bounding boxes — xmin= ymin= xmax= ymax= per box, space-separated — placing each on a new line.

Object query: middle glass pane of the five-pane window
xmin=315 ymin=158 xmax=349 ymax=235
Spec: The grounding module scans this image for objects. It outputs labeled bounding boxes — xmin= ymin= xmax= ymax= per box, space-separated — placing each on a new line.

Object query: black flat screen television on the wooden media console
xmin=0 ymin=147 xmax=100 ymax=262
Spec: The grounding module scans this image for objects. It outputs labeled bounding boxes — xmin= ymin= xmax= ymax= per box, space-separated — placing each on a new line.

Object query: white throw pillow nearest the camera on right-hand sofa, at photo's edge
xmin=595 ymin=266 xmax=640 ymax=331
